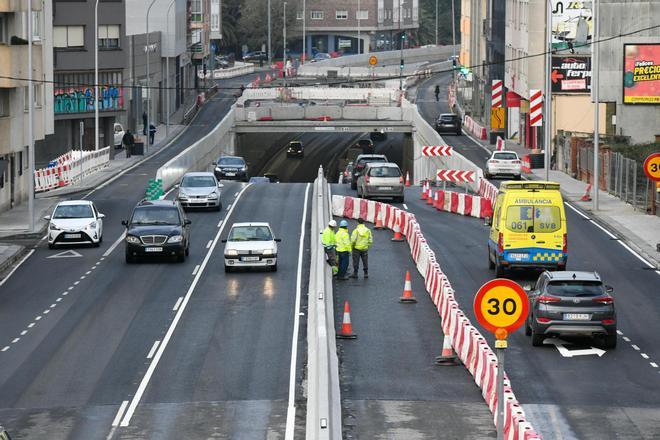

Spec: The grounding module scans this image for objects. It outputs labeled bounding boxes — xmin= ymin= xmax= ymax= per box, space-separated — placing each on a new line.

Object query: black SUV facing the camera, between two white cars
xmin=121 ymin=200 xmax=190 ymax=264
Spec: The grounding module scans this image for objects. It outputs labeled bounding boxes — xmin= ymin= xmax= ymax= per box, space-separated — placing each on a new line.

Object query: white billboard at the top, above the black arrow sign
xmin=552 ymin=0 xmax=593 ymax=55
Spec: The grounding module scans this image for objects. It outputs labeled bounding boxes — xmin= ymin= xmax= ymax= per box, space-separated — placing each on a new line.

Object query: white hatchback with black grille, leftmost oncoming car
xmin=44 ymin=200 xmax=105 ymax=249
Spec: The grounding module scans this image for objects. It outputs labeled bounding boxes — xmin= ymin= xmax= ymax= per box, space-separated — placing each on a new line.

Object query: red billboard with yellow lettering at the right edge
xmin=623 ymin=44 xmax=660 ymax=104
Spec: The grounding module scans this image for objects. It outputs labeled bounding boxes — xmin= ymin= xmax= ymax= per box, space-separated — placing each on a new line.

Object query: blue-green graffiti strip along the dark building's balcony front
xmin=55 ymin=86 xmax=124 ymax=113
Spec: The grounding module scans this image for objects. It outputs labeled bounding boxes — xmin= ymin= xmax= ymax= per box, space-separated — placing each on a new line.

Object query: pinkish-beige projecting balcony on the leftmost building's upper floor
xmin=0 ymin=43 xmax=43 ymax=88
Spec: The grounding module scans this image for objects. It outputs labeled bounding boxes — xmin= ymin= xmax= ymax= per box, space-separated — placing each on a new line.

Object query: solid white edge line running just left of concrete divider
xmin=284 ymin=183 xmax=310 ymax=440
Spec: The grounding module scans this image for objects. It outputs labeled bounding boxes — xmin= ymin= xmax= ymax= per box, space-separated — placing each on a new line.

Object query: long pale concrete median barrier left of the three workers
xmin=305 ymin=167 xmax=342 ymax=440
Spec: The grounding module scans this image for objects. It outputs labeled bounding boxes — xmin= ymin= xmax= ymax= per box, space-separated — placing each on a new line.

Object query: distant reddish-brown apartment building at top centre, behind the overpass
xmin=298 ymin=0 xmax=419 ymax=56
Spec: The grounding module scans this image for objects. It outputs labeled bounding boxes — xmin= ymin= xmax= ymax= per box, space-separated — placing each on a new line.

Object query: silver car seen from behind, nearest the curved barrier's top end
xmin=357 ymin=162 xmax=404 ymax=203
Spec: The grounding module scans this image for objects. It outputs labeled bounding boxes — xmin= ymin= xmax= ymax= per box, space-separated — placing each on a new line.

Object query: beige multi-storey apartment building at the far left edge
xmin=0 ymin=0 xmax=53 ymax=211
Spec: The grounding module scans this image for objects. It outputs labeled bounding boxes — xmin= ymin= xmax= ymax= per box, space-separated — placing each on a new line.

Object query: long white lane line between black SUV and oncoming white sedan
xmin=120 ymin=184 xmax=250 ymax=426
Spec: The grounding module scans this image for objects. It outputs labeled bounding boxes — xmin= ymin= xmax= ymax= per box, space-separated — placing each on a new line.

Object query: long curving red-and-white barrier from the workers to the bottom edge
xmin=332 ymin=195 xmax=541 ymax=440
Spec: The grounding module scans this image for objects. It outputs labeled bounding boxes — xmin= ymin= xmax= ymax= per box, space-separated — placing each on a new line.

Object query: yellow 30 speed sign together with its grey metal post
xmin=473 ymin=278 xmax=529 ymax=440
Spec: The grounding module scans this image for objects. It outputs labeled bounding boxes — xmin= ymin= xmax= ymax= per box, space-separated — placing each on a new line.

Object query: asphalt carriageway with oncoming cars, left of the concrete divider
xmin=0 ymin=74 xmax=308 ymax=439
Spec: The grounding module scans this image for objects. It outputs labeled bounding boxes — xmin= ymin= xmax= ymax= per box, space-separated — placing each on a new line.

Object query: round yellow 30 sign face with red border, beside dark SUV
xmin=473 ymin=278 xmax=529 ymax=333
